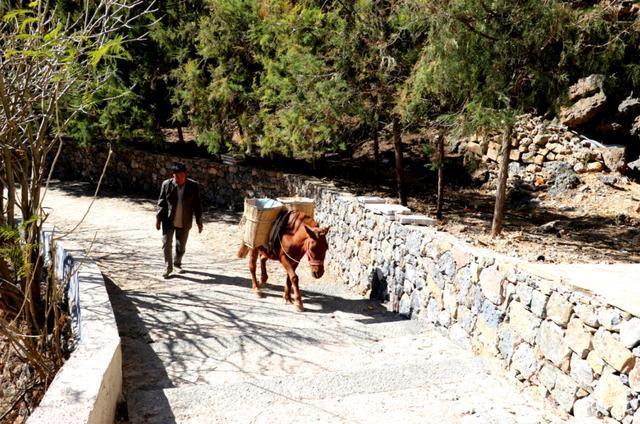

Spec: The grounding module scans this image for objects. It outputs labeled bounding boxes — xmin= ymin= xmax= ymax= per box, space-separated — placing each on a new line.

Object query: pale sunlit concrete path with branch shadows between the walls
xmin=45 ymin=183 xmax=561 ymax=423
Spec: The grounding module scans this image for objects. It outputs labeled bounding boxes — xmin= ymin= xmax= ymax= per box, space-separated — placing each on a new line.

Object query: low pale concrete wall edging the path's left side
xmin=28 ymin=229 xmax=122 ymax=424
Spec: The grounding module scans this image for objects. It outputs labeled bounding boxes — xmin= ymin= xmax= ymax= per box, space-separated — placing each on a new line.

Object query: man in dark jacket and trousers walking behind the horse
xmin=156 ymin=162 xmax=202 ymax=278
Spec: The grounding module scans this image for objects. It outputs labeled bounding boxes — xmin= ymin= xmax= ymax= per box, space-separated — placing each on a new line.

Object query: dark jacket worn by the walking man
xmin=156 ymin=178 xmax=202 ymax=230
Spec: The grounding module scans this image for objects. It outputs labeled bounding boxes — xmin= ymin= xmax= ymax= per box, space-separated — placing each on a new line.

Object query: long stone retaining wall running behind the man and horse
xmin=55 ymin=145 xmax=640 ymax=424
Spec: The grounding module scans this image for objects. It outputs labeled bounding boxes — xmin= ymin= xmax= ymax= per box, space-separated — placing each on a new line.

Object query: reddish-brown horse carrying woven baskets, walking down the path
xmin=238 ymin=211 xmax=329 ymax=311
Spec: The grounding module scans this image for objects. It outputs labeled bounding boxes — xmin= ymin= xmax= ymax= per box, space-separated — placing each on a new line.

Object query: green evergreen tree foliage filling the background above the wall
xmin=53 ymin=0 xmax=640 ymax=161
